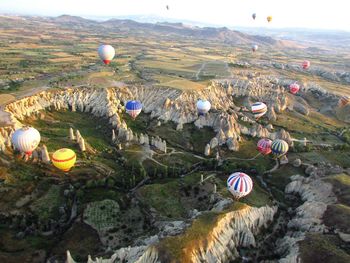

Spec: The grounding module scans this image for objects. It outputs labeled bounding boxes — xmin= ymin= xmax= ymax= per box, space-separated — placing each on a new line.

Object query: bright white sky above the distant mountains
xmin=0 ymin=0 xmax=350 ymax=31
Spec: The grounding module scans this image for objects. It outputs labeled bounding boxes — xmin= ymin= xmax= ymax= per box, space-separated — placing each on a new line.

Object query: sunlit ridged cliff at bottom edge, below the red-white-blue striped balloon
xmin=67 ymin=205 xmax=277 ymax=263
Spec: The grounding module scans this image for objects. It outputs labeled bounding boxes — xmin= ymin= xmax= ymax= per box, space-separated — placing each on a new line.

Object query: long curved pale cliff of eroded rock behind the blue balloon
xmin=0 ymin=85 xmax=292 ymax=156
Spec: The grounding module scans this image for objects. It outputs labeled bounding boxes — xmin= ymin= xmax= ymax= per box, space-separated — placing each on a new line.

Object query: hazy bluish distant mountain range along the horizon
xmin=0 ymin=15 xmax=350 ymax=48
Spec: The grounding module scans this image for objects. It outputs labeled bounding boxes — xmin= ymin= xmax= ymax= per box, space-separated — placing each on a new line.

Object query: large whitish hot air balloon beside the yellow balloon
xmin=11 ymin=126 xmax=40 ymax=156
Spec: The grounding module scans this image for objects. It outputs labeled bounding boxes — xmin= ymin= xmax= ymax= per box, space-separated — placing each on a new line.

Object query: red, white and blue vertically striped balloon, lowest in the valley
xmin=227 ymin=172 xmax=253 ymax=200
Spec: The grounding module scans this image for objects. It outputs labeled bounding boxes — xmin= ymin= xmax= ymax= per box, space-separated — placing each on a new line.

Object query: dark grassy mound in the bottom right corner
xmin=299 ymin=234 xmax=350 ymax=263
